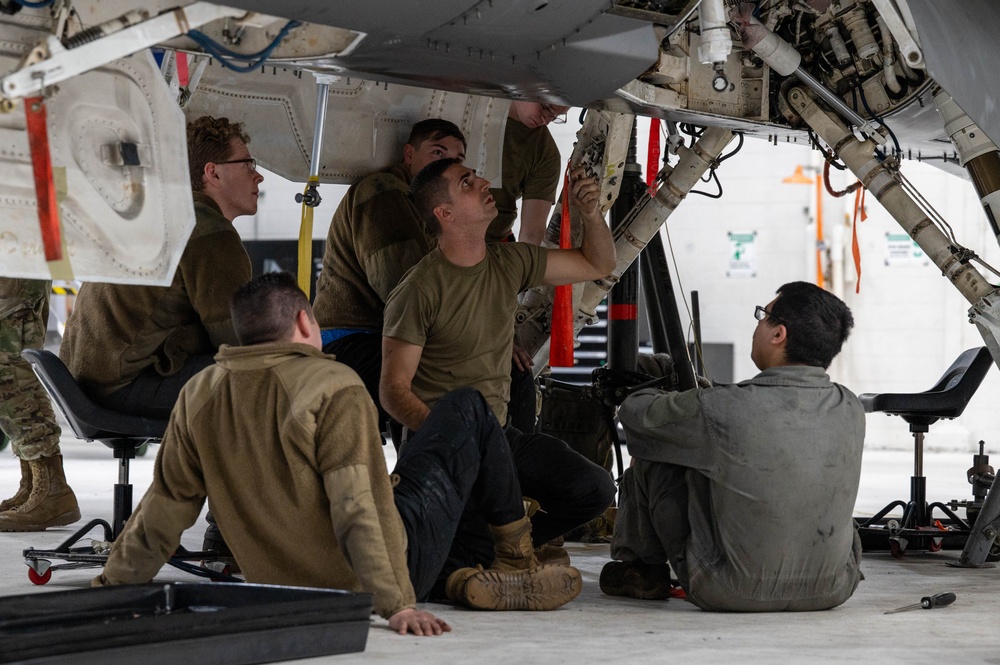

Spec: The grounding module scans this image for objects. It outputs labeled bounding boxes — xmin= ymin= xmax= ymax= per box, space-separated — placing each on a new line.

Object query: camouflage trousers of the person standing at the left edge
xmin=0 ymin=278 xmax=62 ymax=461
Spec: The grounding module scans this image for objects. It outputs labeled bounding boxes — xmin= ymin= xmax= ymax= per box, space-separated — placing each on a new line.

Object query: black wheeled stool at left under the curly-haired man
xmin=21 ymin=349 xmax=219 ymax=584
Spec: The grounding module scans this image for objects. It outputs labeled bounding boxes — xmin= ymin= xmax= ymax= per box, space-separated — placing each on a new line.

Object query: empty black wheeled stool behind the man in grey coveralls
xmin=857 ymin=346 xmax=993 ymax=557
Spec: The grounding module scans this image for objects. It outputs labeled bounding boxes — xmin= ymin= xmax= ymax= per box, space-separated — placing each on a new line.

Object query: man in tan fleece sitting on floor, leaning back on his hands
xmin=94 ymin=273 xmax=582 ymax=635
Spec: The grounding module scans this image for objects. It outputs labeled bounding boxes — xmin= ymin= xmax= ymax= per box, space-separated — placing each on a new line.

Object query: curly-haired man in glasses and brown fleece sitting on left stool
xmin=60 ymin=116 xmax=256 ymax=420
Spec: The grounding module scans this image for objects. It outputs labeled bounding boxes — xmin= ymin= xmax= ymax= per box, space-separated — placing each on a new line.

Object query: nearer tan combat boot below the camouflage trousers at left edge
xmin=0 ymin=455 xmax=80 ymax=531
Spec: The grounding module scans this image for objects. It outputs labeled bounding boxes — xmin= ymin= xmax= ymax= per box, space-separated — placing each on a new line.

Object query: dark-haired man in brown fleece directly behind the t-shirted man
xmin=315 ymin=118 xmax=465 ymax=420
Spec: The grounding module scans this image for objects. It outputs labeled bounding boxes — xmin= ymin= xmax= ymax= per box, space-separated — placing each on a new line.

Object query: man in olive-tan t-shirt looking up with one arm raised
xmin=380 ymin=159 xmax=615 ymax=556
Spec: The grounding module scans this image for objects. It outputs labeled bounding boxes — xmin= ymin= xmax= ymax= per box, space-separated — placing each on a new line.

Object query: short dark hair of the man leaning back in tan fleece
xmin=229 ymin=272 xmax=315 ymax=346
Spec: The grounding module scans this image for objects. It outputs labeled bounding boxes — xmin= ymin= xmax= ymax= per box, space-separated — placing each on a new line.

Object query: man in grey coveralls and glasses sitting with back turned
xmin=600 ymin=282 xmax=865 ymax=612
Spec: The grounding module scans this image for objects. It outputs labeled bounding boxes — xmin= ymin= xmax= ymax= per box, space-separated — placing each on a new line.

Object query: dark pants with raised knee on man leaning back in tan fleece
xmin=393 ymin=388 xmax=524 ymax=601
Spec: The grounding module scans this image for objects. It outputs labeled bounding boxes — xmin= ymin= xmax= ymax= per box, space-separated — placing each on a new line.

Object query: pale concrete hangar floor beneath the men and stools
xmin=0 ymin=439 xmax=1000 ymax=665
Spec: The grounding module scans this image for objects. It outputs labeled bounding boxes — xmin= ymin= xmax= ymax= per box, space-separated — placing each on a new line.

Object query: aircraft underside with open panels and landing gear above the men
xmin=0 ymin=0 xmax=1000 ymax=358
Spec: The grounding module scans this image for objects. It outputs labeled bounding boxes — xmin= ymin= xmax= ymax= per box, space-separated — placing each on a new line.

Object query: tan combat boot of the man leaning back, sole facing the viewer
xmin=445 ymin=517 xmax=583 ymax=610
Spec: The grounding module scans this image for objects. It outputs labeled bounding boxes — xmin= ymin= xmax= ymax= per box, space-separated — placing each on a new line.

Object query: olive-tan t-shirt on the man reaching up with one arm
xmin=382 ymin=242 xmax=546 ymax=424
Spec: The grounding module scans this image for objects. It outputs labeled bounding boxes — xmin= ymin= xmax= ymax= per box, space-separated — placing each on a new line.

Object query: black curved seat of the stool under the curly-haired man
xmin=21 ymin=349 xmax=167 ymax=440
